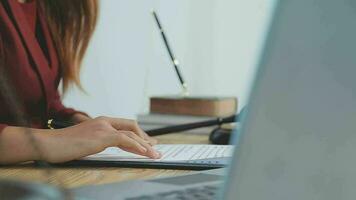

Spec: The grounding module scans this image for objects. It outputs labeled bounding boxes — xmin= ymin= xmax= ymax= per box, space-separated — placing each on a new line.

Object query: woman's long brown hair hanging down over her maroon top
xmin=38 ymin=0 xmax=98 ymax=92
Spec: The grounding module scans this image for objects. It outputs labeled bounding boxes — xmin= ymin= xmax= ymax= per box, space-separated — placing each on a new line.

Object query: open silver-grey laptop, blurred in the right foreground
xmin=73 ymin=0 xmax=356 ymax=200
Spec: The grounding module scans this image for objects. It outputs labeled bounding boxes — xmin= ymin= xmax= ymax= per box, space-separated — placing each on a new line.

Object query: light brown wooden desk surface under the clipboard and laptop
xmin=0 ymin=134 xmax=209 ymax=188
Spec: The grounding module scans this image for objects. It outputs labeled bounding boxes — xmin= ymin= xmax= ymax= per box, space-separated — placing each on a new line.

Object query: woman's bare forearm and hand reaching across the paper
xmin=0 ymin=117 xmax=161 ymax=164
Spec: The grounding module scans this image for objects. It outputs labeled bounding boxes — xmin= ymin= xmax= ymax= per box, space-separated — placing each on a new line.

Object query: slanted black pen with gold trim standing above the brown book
xmin=152 ymin=10 xmax=189 ymax=96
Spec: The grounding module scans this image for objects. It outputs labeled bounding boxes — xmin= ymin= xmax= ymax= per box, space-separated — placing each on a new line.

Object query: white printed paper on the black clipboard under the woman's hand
xmin=83 ymin=144 xmax=234 ymax=162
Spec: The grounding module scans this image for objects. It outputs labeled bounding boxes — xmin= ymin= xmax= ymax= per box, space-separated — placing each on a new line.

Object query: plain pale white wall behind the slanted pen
xmin=64 ymin=0 xmax=273 ymax=118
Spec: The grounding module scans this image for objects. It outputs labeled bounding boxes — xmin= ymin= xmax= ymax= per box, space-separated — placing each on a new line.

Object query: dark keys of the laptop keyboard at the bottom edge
xmin=126 ymin=185 xmax=219 ymax=200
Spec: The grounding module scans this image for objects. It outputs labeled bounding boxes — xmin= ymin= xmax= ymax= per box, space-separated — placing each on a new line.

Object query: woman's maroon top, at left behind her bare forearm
xmin=0 ymin=0 xmax=84 ymax=132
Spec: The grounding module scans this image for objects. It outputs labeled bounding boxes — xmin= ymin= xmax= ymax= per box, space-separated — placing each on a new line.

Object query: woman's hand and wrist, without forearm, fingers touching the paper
xmin=36 ymin=117 xmax=161 ymax=163
